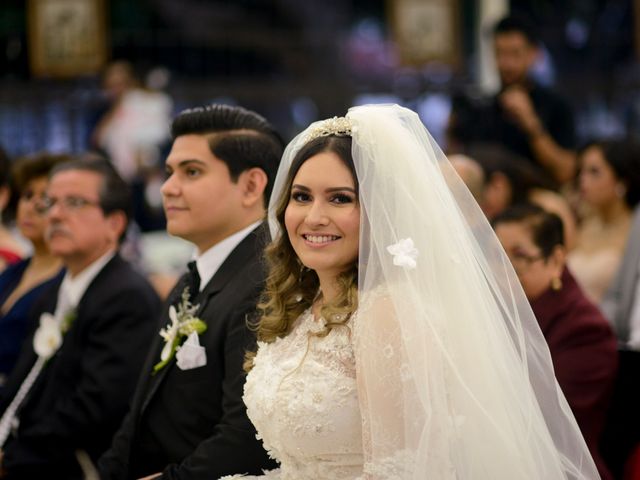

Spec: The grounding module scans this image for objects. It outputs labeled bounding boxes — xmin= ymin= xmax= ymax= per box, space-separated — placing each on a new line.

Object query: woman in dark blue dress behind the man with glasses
xmin=0 ymin=154 xmax=69 ymax=391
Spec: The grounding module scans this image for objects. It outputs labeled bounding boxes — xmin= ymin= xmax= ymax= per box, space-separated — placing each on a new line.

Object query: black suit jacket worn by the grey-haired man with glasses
xmin=0 ymin=255 xmax=160 ymax=479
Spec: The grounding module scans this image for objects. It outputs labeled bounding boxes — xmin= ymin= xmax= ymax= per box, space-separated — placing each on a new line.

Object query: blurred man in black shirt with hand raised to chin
xmin=449 ymin=16 xmax=576 ymax=184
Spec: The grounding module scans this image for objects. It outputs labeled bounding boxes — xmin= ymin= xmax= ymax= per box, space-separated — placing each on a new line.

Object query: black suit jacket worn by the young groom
xmin=99 ymin=226 xmax=274 ymax=480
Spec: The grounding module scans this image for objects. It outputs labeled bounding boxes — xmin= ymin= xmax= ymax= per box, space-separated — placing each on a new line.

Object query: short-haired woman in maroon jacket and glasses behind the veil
xmin=493 ymin=204 xmax=618 ymax=480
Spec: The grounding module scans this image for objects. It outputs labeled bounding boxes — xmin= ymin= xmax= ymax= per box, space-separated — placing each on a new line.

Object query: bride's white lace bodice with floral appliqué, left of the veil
xmin=244 ymin=311 xmax=363 ymax=480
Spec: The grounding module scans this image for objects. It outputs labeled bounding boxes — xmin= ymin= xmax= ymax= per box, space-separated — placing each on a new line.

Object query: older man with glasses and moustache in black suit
xmin=0 ymin=159 xmax=160 ymax=479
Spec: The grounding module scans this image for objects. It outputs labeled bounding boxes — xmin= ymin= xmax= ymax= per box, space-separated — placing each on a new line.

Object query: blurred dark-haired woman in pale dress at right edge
xmin=568 ymin=140 xmax=640 ymax=304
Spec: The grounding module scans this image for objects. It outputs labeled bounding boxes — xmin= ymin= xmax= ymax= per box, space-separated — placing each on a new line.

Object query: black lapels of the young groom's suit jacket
xmin=141 ymin=224 xmax=268 ymax=412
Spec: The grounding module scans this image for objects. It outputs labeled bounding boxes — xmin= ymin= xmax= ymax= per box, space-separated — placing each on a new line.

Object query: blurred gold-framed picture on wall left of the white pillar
xmin=388 ymin=0 xmax=461 ymax=67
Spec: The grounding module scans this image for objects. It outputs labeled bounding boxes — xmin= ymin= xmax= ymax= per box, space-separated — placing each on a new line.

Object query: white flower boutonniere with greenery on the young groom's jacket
xmin=153 ymin=287 xmax=207 ymax=374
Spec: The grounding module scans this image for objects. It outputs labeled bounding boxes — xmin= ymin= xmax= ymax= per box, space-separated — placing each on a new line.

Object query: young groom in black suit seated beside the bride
xmin=99 ymin=105 xmax=283 ymax=479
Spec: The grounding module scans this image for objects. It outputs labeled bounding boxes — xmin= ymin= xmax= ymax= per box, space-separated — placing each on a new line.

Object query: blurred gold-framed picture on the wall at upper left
xmin=28 ymin=0 xmax=107 ymax=77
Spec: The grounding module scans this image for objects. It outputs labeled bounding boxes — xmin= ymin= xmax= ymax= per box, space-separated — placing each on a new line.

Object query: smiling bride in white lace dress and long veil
xmin=225 ymin=105 xmax=599 ymax=480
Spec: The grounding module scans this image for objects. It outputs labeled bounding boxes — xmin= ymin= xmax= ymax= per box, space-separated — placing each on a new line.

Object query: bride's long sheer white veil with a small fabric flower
xmin=269 ymin=105 xmax=599 ymax=480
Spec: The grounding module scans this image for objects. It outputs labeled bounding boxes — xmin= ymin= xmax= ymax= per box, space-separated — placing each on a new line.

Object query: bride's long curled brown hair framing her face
xmin=244 ymin=135 xmax=358 ymax=371
